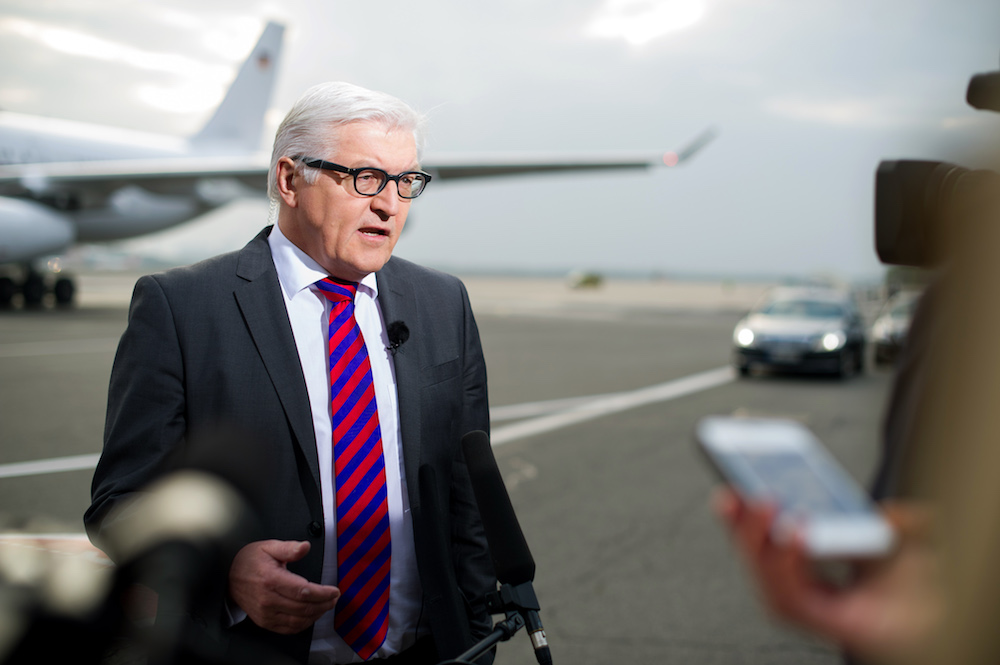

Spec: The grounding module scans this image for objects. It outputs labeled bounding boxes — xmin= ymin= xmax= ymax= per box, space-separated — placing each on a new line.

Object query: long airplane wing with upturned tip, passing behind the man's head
xmin=0 ymin=128 xmax=716 ymax=193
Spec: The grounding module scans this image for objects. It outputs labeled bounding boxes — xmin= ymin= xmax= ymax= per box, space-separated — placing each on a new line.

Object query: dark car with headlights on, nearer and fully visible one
xmin=733 ymin=287 xmax=865 ymax=377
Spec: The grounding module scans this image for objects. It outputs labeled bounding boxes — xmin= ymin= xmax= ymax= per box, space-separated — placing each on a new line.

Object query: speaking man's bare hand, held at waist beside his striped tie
xmin=229 ymin=540 xmax=340 ymax=635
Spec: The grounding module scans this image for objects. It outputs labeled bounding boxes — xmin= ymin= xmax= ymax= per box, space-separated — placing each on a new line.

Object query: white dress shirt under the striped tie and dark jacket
xmin=268 ymin=224 xmax=422 ymax=664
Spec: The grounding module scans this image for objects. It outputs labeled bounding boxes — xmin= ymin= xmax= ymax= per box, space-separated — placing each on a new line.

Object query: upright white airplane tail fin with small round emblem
xmin=191 ymin=22 xmax=285 ymax=151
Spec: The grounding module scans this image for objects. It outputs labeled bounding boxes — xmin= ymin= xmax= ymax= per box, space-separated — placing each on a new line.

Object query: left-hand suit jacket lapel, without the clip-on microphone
xmin=234 ymin=226 xmax=320 ymax=489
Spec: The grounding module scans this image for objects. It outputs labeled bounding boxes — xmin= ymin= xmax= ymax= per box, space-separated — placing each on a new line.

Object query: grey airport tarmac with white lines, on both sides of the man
xmin=0 ymin=274 xmax=890 ymax=665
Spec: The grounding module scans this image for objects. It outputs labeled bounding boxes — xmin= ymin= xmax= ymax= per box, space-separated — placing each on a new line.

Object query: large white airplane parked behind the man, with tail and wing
xmin=0 ymin=22 xmax=716 ymax=307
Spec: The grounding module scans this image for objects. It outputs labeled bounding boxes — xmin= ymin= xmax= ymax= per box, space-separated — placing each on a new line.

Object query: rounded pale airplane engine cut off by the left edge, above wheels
xmin=0 ymin=197 xmax=76 ymax=263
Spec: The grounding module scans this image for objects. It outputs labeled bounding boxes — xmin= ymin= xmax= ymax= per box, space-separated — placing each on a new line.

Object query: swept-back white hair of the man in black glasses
xmin=267 ymin=81 xmax=426 ymax=201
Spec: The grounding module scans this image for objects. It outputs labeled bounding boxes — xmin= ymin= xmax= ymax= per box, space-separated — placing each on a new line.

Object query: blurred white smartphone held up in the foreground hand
xmin=695 ymin=416 xmax=894 ymax=559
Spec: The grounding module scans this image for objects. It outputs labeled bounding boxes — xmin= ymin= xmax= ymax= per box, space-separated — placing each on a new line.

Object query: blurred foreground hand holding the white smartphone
xmin=715 ymin=490 xmax=943 ymax=662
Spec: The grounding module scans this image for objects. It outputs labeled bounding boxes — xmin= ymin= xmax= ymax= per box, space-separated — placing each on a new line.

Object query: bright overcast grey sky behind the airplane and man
xmin=0 ymin=0 xmax=1000 ymax=279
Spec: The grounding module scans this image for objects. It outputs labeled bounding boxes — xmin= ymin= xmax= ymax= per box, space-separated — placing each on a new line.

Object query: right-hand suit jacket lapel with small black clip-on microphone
xmin=376 ymin=259 xmax=421 ymax=505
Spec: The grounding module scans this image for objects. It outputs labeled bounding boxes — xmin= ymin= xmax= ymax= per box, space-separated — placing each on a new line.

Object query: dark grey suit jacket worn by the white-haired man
xmin=84 ymin=227 xmax=496 ymax=662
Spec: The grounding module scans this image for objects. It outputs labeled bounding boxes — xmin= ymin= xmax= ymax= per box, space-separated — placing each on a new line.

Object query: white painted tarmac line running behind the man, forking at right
xmin=0 ymin=364 xmax=736 ymax=478
